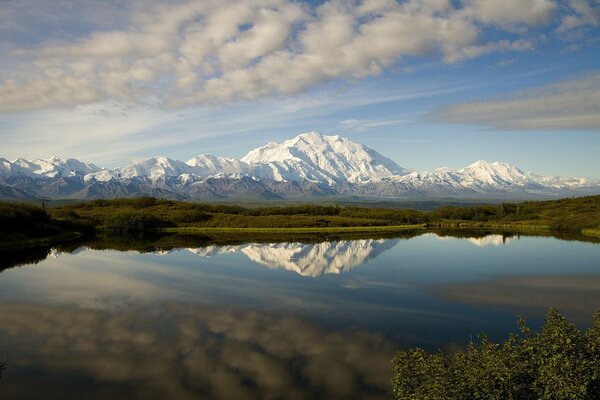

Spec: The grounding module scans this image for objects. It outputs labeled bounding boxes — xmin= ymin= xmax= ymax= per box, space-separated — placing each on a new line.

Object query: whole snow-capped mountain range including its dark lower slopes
xmin=0 ymin=132 xmax=600 ymax=200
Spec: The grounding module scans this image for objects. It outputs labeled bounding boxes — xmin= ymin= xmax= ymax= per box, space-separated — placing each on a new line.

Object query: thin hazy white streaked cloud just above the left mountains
xmin=0 ymin=81 xmax=457 ymax=167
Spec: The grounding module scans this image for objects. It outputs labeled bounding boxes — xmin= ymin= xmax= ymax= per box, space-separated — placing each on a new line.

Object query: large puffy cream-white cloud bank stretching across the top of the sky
xmin=0 ymin=0 xmax=572 ymax=112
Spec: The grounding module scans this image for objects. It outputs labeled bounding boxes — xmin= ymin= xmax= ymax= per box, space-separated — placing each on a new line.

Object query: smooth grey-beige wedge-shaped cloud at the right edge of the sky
xmin=434 ymin=73 xmax=600 ymax=130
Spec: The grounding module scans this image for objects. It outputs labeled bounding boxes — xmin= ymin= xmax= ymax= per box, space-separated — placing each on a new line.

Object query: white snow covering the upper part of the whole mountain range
xmin=0 ymin=132 xmax=600 ymax=193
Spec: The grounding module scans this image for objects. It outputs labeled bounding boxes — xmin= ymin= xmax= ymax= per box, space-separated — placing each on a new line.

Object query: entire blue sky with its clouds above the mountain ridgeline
xmin=0 ymin=0 xmax=600 ymax=179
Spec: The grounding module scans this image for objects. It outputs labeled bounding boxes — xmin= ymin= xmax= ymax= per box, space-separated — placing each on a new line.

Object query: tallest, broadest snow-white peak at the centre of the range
xmin=242 ymin=132 xmax=408 ymax=185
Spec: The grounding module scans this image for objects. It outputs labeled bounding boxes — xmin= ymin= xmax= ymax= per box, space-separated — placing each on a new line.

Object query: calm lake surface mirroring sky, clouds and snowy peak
xmin=0 ymin=234 xmax=600 ymax=399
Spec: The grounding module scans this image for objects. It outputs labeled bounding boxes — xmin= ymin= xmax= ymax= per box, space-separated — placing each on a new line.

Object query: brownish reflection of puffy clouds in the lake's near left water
xmin=0 ymin=304 xmax=394 ymax=399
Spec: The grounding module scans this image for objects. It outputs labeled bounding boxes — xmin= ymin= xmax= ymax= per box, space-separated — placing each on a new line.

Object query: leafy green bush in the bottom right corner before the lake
xmin=392 ymin=309 xmax=600 ymax=400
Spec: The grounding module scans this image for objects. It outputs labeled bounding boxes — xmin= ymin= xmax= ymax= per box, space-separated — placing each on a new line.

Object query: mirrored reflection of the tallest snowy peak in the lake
xmin=188 ymin=239 xmax=399 ymax=277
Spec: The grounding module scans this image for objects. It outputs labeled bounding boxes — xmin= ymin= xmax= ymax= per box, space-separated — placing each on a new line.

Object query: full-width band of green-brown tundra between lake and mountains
xmin=0 ymin=196 xmax=600 ymax=244
